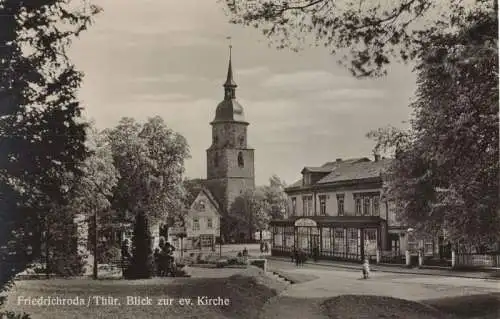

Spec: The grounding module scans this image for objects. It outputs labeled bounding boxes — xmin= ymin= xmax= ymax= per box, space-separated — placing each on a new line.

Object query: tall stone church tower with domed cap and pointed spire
xmin=206 ymin=46 xmax=255 ymax=239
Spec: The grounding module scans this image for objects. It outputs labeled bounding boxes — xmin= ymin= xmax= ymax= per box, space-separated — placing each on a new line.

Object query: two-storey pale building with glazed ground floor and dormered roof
xmin=271 ymin=156 xmax=414 ymax=261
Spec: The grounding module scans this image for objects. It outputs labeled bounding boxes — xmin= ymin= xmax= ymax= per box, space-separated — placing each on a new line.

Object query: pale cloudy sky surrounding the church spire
xmin=71 ymin=0 xmax=415 ymax=184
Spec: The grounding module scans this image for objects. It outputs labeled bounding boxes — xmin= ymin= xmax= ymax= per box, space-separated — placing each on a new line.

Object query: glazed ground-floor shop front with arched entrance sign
xmin=271 ymin=216 xmax=387 ymax=261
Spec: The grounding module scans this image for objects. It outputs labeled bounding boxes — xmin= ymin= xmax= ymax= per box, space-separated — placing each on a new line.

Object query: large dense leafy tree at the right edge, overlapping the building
xmin=370 ymin=6 xmax=500 ymax=250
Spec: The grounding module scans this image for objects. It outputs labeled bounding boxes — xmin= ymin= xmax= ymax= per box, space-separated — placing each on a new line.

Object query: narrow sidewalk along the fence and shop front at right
xmin=267 ymin=256 xmax=500 ymax=281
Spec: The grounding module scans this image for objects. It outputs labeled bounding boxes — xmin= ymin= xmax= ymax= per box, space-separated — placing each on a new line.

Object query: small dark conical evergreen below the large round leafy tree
xmin=125 ymin=212 xmax=153 ymax=279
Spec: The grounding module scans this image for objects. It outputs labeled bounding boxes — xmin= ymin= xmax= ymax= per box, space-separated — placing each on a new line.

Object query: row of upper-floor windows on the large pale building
xmin=292 ymin=193 xmax=380 ymax=216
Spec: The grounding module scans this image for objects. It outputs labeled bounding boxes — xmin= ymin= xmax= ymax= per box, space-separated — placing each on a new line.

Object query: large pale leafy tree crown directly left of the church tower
xmin=107 ymin=116 xmax=189 ymax=225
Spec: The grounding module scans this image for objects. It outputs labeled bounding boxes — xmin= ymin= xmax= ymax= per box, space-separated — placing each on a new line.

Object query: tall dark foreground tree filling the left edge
xmin=0 ymin=0 xmax=99 ymax=296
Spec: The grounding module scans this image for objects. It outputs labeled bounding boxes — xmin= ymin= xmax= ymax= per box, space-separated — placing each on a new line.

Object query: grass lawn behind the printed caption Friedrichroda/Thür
xmin=1 ymin=267 xmax=283 ymax=319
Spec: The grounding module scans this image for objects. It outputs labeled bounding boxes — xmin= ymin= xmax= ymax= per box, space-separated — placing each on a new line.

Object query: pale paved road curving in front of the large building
xmin=269 ymin=260 xmax=500 ymax=300
